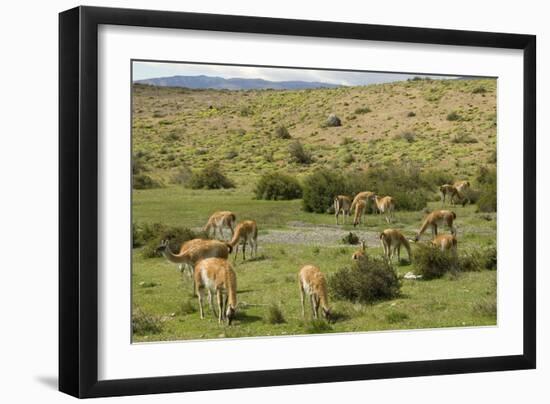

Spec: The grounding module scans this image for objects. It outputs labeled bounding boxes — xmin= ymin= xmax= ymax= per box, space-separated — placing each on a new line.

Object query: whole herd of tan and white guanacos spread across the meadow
xmin=158 ymin=181 xmax=470 ymax=325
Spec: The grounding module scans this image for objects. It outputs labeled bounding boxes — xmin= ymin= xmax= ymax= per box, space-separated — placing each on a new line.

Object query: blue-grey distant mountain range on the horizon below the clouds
xmin=134 ymin=75 xmax=340 ymax=90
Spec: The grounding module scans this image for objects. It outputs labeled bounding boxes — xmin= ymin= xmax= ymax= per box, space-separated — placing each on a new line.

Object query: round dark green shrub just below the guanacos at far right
xmin=414 ymin=243 xmax=458 ymax=280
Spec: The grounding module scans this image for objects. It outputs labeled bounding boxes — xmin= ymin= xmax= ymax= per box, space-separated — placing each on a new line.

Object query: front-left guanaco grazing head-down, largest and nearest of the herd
xmin=195 ymin=258 xmax=237 ymax=325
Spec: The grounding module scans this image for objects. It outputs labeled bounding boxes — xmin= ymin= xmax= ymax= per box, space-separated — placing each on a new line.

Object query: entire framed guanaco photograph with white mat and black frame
xmin=59 ymin=7 xmax=536 ymax=398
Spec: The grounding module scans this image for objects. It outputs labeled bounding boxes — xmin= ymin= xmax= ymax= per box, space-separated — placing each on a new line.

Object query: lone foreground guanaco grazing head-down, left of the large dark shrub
xmin=298 ymin=265 xmax=330 ymax=320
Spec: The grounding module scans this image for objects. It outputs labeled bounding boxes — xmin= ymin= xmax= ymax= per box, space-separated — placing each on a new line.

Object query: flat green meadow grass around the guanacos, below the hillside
xmin=132 ymin=186 xmax=497 ymax=341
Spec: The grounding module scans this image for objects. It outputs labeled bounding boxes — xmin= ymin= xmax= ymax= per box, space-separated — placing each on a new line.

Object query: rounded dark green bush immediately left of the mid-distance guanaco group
xmin=302 ymin=169 xmax=345 ymax=213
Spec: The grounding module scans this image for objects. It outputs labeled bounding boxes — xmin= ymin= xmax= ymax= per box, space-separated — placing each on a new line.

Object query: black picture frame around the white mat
xmin=59 ymin=7 xmax=536 ymax=398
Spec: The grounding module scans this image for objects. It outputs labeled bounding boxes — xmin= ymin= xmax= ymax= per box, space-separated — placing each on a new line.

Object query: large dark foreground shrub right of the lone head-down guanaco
xmin=329 ymin=259 xmax=401 ymax=303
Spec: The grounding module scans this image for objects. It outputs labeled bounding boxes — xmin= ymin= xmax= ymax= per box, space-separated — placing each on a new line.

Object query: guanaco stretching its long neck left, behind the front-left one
xmin=157 ymin=238 xmax=232 ymax=272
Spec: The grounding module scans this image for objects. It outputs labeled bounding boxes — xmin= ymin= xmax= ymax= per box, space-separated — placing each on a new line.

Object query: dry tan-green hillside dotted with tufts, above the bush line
xmin=133 ymin=79 xmax=497 ymax=182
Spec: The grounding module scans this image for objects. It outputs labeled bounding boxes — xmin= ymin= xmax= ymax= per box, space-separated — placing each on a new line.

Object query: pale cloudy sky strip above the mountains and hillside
xmin=133 ymin=62 xmax=460 ymax=86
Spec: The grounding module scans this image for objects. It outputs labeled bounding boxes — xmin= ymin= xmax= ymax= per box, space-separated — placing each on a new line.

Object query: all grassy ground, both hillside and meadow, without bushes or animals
xmin=132 ymin=80 xmax=497 ymax=342
